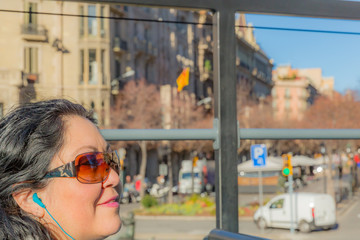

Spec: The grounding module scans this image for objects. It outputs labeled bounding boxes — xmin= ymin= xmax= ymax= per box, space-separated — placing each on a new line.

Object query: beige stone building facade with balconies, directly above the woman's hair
xmin=0 ymin=0 xmax=110 ymax=127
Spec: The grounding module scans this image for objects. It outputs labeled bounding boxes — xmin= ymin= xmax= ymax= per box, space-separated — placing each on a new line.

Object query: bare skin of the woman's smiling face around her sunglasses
xmin=38 ymin=116 xmax=121 ymax=240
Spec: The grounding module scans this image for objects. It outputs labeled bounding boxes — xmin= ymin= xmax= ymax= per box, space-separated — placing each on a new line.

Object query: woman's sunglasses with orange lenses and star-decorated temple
xmin=44 ymin=151 xmax=120 ymax=184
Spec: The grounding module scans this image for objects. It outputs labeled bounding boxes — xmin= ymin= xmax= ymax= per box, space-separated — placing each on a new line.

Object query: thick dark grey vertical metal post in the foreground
xmin=213 ymin=8 xmax=239 ymax=233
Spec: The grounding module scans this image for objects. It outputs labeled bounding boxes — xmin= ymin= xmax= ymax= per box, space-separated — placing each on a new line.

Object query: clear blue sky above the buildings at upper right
xmin=246 ymin=14 xmax=360 ymax=93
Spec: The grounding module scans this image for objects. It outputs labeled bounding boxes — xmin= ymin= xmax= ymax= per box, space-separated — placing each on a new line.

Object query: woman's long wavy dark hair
xmin=0 ymin=99 xmax=96 ymax=240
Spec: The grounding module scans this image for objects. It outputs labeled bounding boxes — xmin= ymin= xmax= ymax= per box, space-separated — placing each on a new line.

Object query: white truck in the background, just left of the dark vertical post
xmin=179 ymin=160 xmax=206 ymax=194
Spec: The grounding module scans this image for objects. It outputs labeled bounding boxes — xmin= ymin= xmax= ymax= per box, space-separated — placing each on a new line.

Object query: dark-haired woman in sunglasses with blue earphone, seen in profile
xmin=0 ymin=99 xmax=121 ymax=240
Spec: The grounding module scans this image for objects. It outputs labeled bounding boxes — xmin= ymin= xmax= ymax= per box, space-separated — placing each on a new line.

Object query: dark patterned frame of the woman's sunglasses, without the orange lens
xmin=44 ymin=150 xmax=120 ymax=184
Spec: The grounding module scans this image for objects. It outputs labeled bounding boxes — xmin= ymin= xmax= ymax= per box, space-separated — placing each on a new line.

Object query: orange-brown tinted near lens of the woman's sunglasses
xmin=76 ymin=153 xmax=110 ymax=183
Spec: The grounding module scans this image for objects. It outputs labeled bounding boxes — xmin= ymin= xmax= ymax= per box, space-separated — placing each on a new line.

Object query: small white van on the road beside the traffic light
xmin=254 ymin=192 xmax=336 ymax=232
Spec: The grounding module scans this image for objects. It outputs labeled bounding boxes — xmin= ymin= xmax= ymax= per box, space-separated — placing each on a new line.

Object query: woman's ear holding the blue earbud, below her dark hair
xmin=12 ymin=189 xmax=45 ymax=218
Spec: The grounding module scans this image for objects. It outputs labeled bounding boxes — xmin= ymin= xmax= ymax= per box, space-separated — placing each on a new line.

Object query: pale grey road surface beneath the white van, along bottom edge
xmin=131 ymin=191 xmax=360 ymax=240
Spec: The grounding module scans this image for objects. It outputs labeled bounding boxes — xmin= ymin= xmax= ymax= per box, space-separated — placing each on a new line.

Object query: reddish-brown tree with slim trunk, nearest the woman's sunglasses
xmin=111 ymin=79 xmax=161 ymax=197
